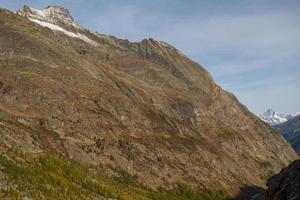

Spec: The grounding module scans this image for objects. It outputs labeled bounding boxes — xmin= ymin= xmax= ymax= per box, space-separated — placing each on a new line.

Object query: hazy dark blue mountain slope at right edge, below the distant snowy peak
xmin=274 ymin=114 xmax=300 ymax=153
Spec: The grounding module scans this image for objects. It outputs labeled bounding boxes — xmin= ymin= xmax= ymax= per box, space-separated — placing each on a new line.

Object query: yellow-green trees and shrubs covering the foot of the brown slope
xmin=0 ymin=153 xmax=229 ymax=200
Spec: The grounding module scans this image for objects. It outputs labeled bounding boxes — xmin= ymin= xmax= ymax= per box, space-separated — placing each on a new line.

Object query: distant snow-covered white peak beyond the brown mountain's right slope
xmin=259 ymin=109 xmax=296 ymax=126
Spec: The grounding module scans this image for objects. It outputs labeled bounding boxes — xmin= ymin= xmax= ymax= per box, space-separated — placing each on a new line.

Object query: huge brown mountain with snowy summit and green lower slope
xmin=0 ymin=6 xmax=298 ymax=199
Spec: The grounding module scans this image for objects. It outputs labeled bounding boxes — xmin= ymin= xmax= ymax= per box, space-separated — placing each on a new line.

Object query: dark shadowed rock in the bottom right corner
xmin=266 ymin=160 xmax=300 ymax=200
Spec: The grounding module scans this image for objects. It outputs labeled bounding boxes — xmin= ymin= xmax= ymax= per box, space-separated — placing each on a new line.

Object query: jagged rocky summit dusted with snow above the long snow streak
xmin=17 ymin=5 xmax=82 ymax=29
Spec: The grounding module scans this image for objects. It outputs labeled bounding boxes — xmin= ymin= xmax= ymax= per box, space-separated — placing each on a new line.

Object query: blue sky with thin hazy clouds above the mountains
xmin=0 ymin=0 xmax=300 ymax=114
